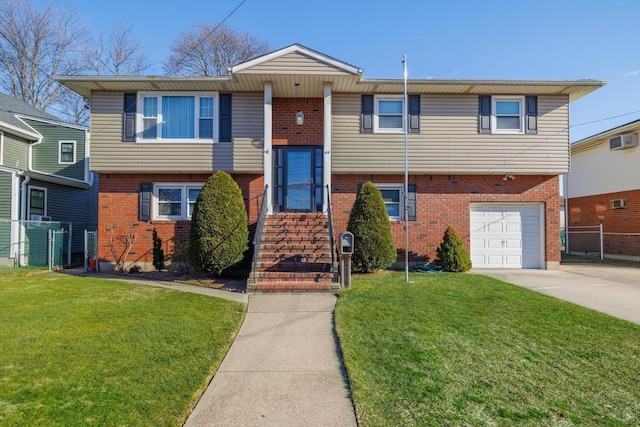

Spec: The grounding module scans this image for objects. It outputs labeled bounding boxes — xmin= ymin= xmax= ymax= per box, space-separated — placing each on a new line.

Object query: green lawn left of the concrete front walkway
xmin=0 ymin=273 xmax=245 ymax=426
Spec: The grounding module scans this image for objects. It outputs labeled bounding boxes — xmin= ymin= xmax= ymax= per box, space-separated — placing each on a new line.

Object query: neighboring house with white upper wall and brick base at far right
xmin=565 ymin=120 xmax=640 ymax=260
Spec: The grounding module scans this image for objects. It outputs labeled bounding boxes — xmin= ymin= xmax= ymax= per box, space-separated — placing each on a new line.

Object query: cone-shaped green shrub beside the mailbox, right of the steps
xmin=347 ymin=182 xmax=396 ymax=273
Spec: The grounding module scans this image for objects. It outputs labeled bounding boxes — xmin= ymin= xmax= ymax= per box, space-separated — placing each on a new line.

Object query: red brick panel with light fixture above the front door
xmin=271 ymin=98 xmax=324 ymax=147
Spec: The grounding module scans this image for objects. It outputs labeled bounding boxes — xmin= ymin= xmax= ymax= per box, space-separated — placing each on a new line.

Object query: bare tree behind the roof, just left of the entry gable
xmin=164 ymin=24 xmax=269 ymax=76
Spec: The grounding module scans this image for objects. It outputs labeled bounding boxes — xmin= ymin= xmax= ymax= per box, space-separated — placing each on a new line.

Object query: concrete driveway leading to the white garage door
xmin=473 ymin=264 xmax=640 ymax=324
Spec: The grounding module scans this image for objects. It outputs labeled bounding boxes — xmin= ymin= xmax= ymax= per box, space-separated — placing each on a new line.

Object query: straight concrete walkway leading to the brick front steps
xmin=185 ymin=294 xmax=356 ymax=427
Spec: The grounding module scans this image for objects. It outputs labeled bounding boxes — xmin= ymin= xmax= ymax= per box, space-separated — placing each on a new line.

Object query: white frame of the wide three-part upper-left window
xmin=136 ymin=92 xmax=220 ymax=144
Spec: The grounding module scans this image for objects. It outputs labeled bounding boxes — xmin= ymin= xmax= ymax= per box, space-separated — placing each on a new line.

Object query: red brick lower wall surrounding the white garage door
xmin=331 ymin=174 xmax=560 ymax=267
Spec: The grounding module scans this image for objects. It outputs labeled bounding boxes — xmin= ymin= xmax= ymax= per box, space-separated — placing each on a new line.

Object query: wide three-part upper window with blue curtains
xmin=138 ymin=93 xmax=217 ymax=142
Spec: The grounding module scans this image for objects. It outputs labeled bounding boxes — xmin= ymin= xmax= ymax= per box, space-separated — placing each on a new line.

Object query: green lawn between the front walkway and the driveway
xmin=336 ymin=273 xmax=640 ymax=426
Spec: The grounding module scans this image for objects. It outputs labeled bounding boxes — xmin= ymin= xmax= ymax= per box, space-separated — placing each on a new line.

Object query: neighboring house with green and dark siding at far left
xmin=0 ymin=94 xmax=97 ymax=264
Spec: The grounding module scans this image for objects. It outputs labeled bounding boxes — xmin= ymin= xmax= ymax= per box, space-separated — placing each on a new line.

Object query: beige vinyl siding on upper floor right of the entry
xmin=332 ymin=94 xmax=569 ymax=174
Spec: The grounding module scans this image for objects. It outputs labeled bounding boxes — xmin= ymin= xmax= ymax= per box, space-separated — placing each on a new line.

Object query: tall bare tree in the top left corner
xmin=0 ymin=0 xmax=88 ymax=111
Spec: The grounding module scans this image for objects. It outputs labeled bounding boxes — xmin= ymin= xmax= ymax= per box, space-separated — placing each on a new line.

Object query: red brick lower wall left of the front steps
xmin=98 ymin=174 xmax=264 ymax=269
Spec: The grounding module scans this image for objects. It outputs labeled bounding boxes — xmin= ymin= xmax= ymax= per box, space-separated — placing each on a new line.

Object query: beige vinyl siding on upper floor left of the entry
xmin=91 ymin=92 xmax=263 ymax=173
